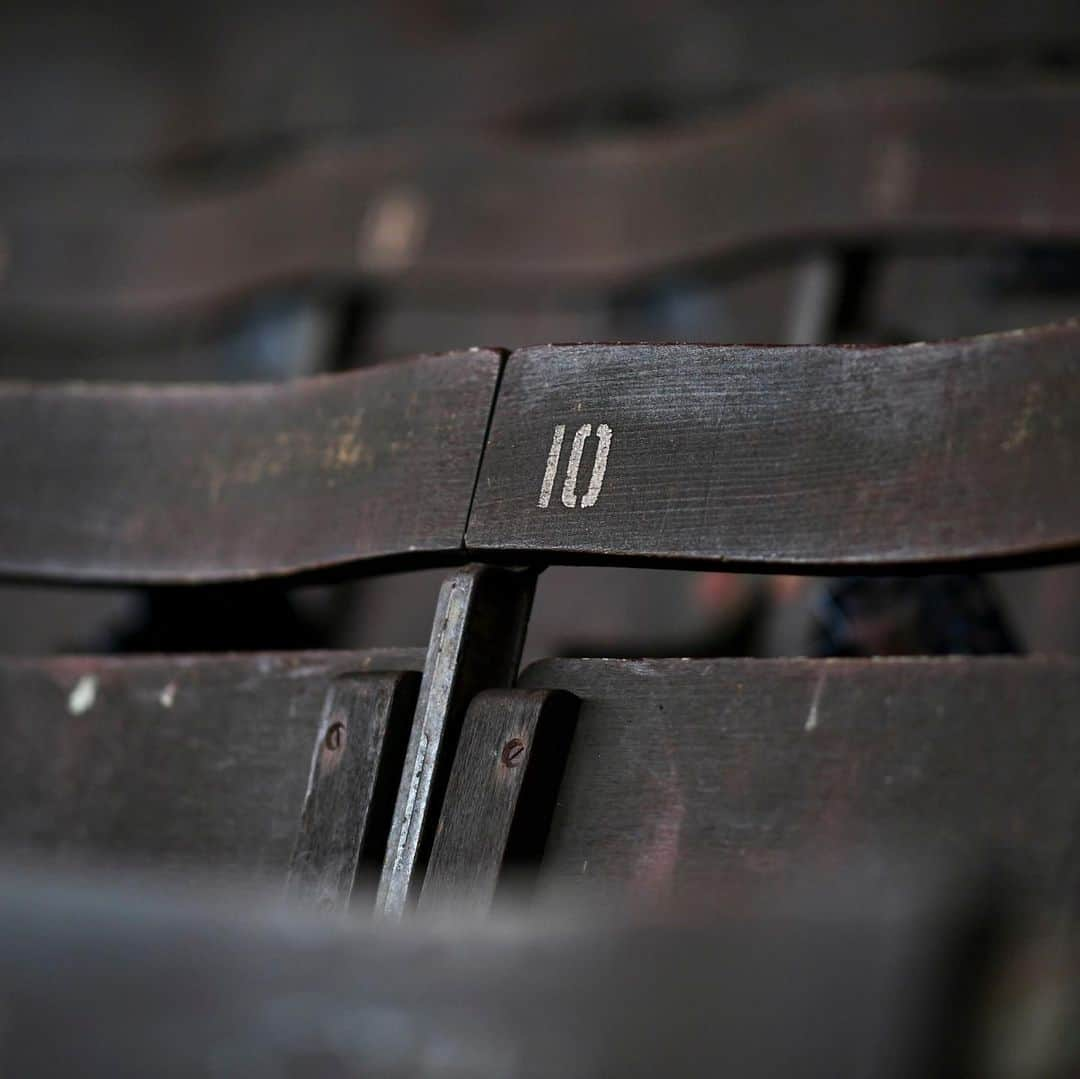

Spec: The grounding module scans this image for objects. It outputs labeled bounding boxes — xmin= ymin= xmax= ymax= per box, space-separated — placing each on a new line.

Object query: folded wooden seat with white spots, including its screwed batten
xmin=0 ymin=649 xmax=423 ymax=894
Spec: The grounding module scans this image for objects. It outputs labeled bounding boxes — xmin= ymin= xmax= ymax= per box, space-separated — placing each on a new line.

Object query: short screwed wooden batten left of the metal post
xmin=288 ymin=671 xmax=420 ymax=911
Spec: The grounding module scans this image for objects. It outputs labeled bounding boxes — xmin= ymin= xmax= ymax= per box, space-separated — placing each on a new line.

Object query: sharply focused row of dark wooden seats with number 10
xmin=0 ymin=325 xmax=1080 ymax=915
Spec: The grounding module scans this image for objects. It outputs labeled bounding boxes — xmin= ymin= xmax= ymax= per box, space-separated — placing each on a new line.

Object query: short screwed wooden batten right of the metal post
xmin=419 ymin=689 xmax=577 ymax=913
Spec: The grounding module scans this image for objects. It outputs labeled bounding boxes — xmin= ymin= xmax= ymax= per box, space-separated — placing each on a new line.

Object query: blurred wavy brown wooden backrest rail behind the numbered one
xmin=6 ymin=79 xmax=1080 ymax=325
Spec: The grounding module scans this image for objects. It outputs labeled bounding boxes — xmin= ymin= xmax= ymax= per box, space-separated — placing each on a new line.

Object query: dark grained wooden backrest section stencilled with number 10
xmin=467 ymin=323 xmax=1080 ymax=569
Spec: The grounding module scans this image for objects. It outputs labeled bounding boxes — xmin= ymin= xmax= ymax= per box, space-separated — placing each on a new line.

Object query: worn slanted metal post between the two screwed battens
xmin=376 ymin=566 xmax=536 ymax=918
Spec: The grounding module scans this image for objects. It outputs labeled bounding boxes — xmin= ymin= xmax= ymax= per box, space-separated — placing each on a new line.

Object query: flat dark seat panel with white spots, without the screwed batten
xmin=0 ymin=649 xmax=423 ymax=882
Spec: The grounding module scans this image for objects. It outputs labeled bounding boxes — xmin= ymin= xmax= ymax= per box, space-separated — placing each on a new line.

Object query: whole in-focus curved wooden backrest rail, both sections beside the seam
xmin=0 ymin=323 xmax=1080 ymax=583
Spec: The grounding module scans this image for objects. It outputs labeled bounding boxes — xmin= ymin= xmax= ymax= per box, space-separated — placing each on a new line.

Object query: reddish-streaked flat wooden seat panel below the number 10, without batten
xmin=521 ymin=658 xmax=1080 ymax=900
